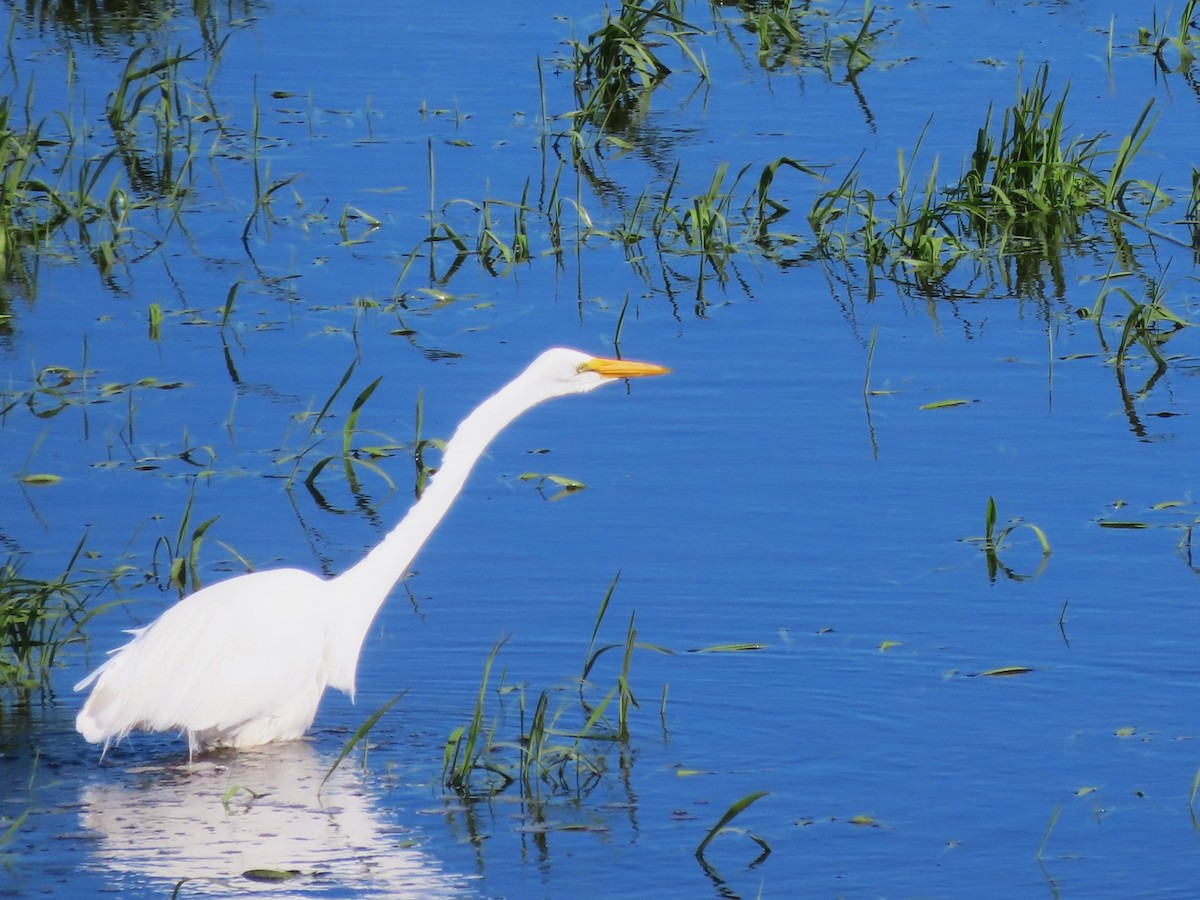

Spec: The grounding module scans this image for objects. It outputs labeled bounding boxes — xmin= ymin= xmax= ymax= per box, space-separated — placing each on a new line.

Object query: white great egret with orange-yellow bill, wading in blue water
xmin=74 ymin=348 xmax=670 ymax=752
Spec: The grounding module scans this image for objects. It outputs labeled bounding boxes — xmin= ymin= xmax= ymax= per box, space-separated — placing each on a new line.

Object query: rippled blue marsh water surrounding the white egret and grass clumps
xmin=0 ymin=4 xmax=1200 ymax=896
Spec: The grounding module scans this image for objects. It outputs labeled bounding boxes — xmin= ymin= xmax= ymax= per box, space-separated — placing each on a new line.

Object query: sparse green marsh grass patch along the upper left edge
xmin=0 ymin=34 xmax=228 ymax=293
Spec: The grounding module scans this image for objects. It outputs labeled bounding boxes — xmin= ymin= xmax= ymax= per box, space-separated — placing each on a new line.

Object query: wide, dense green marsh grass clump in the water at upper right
xmin=809 ymin=66 xmax=1169 ymax=293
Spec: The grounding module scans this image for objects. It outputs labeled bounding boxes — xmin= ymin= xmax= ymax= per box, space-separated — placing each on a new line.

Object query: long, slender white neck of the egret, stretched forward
xmin=326 ymin=382 xmax=541 ymax=698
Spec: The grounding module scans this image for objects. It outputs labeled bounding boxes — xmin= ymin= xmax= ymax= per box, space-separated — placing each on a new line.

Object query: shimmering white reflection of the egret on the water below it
xmin=80 ymin=742 xmax=468 ymax=898
